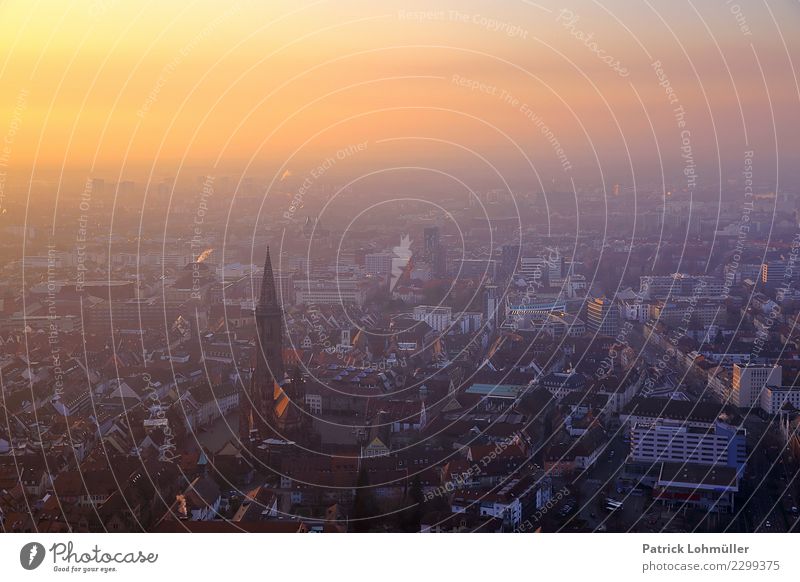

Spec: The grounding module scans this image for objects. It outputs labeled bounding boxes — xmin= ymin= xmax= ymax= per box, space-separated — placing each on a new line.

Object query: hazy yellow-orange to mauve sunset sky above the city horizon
xmin=0 ymin=0 xmax=800 ymax=190
